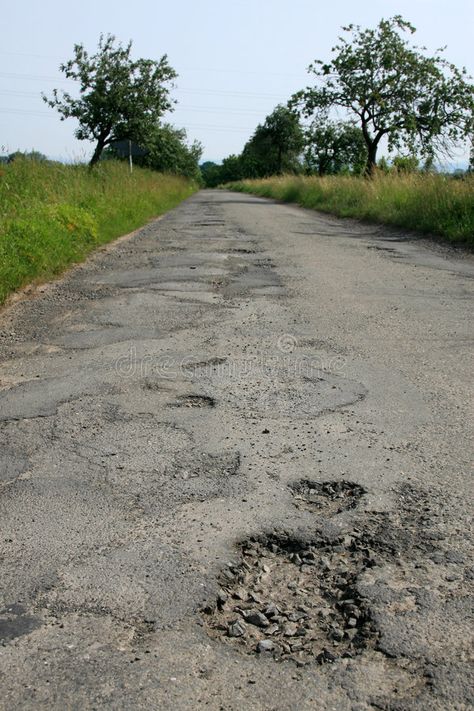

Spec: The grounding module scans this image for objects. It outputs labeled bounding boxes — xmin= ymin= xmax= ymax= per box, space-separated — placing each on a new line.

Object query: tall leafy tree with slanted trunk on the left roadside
xmin=43 ymin=35 xmax=177 ymax=166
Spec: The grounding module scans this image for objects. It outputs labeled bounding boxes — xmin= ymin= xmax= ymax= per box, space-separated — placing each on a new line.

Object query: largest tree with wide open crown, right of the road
xmin=290 ymin=15 xmax=474 ymax=173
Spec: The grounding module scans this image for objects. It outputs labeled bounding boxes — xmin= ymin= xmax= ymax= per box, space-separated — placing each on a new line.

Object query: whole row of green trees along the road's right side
xmin=201 ymin=15 xmax=474 ymax=186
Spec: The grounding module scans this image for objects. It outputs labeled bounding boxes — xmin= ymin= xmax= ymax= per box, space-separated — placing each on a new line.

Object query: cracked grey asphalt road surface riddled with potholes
xmin=0 ymin=191 xmax=474 ymax=711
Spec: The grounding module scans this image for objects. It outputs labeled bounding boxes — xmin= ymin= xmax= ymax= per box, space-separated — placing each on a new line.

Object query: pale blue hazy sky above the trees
xmin=0 ymin=0 xmax=474 ymax=162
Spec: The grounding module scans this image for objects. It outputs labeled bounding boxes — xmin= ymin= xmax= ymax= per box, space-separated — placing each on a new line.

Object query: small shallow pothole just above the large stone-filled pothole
xmin=290 ymin=479 xmax=367 ymax=515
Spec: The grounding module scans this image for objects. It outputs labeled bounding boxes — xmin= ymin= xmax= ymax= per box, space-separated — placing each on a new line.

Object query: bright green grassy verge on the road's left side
xmin=0 ymin=160 xmax=197 ymax=304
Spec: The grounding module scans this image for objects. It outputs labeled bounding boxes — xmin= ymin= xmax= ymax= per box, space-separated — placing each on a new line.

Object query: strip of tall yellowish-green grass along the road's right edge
xmin=225 ymin=174 xmax=474 ymax=246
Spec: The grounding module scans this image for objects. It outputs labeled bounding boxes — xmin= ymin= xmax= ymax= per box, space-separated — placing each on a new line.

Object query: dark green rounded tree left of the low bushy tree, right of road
xmin=242 ymin=106 xmax=304 ymax=177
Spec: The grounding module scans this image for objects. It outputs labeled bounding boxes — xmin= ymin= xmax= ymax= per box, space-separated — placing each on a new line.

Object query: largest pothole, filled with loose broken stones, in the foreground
xmin=203 ymin=533 xmax=376 ymax=665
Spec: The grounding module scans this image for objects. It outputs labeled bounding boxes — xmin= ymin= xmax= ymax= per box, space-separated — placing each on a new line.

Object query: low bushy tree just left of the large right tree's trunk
xmin=304 ymin=120 xmax=367 ymax=175
